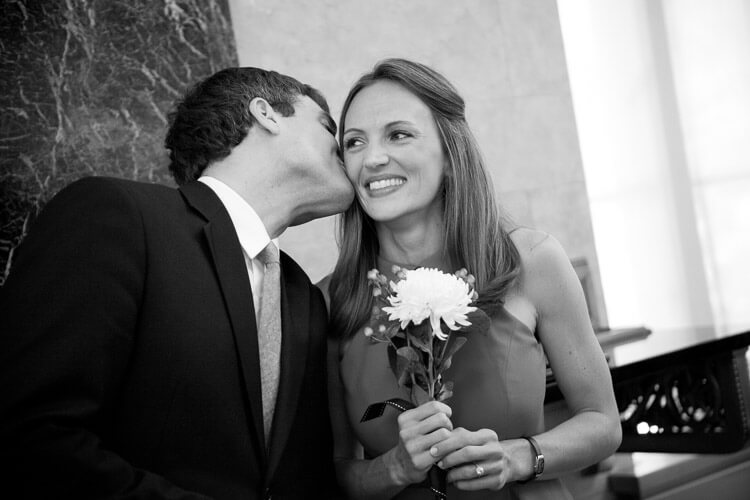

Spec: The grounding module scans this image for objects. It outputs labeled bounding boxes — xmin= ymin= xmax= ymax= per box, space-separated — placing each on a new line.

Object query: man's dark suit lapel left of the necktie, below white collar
xmin=180 ymin=182 xmax=268 ymax=464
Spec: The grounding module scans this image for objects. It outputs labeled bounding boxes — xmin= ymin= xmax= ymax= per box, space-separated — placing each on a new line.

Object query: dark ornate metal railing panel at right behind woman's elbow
xmin=546 ymin=331 xmax=750 ymax=453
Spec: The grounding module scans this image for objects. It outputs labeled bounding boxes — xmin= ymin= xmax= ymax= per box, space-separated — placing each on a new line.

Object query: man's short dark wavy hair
xmin=164 ymin=68 xmax=329 ymax=185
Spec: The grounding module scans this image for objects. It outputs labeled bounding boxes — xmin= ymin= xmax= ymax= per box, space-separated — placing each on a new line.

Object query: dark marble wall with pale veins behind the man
xmin=0 ymin=0 xmax=237 ymax=279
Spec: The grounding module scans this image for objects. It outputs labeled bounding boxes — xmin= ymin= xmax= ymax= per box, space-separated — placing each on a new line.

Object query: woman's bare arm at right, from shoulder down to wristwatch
xmin=526 ymin=233 xmax=622 ymax=477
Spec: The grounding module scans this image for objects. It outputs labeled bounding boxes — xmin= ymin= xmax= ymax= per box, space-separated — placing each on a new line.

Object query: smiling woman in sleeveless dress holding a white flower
xmin=329 ymin=59 xmax=621 ymax=500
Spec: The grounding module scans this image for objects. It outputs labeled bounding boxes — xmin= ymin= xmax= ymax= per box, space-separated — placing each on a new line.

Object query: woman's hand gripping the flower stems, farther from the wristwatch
xmin=388 ymin=401 xmax=453 ymax=485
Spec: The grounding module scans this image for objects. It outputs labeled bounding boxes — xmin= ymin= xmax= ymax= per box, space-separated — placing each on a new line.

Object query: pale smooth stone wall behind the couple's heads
xmin=229 ymin=0 xmax=606 ymax=323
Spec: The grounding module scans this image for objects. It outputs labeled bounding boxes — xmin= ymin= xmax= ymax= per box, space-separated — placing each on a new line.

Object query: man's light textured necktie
xmin=258 ymin=242 xmax=281 ymax=443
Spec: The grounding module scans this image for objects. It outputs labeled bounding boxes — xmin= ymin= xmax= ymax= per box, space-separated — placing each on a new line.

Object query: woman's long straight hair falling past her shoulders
xmin=329 ymin=59 xmax=520 ymax=337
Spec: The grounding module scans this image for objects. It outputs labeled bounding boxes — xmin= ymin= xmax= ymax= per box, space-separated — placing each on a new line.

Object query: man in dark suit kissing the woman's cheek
xmin=0 ymin=68 xmax=353 ymax=500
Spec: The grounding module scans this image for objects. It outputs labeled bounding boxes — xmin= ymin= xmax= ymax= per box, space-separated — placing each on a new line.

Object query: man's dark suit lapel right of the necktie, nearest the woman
xmin=267 ymin=252 xmax=308 ymax=480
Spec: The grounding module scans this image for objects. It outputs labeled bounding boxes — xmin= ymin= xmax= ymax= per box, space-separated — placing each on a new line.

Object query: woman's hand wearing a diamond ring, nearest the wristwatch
xmin=435 ymin=427 xmax=514 ymax=490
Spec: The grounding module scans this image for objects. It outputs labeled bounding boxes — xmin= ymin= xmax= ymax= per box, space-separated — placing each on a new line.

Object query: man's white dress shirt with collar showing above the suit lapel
xmin=198 ymin=175 xmax=279 ymax=320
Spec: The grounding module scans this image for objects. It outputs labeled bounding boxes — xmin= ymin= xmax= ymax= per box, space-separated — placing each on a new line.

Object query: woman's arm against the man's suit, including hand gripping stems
xmin=328 ymin=340 xmax=453 ymax=499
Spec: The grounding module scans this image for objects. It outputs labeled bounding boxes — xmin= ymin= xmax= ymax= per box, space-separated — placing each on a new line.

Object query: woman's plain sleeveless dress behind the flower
xmin=340 ymin=259 xmax=571 ymax=500
